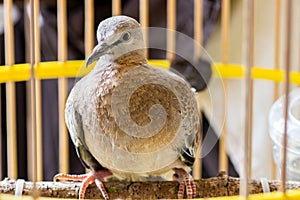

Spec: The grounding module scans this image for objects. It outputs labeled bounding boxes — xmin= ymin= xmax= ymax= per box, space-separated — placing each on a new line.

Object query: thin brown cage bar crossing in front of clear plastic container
xmin=281 ymin=0 xmax=292 ymax=193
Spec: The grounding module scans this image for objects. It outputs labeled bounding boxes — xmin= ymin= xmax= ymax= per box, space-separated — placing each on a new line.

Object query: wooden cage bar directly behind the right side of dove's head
xmin=140 ymin=0 xmax=149 ymax=57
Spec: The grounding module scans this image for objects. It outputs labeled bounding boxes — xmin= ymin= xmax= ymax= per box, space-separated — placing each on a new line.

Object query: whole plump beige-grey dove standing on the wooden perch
xmin=54 ymin=15 xmax=200 ymax=199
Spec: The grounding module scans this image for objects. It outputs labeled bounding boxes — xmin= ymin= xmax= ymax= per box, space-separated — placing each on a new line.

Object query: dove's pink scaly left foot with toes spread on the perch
xmin=53 ymin=170 xmax=112 ymax=199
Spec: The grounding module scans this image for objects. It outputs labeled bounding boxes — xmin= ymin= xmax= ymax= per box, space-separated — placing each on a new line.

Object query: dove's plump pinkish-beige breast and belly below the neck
xmin=85 ymin=67 xmax=199 ymax=173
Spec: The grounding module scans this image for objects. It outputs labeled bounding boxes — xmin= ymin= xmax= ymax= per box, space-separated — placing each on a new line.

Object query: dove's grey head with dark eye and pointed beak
xmin=86 ymin=16 xmax=145 ymax=66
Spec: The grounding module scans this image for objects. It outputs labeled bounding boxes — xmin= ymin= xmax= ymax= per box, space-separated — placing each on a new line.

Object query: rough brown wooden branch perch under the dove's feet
xmin=0 ymin=172 xmax=300 ymax=199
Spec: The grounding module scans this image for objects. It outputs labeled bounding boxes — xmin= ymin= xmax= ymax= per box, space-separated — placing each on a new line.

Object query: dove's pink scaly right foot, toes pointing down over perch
xmin=173 ymin=168 xmax=196 ymax=199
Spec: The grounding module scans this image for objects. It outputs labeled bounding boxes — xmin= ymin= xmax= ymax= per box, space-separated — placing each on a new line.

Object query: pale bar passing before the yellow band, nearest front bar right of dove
xmin=240 ymin=0 xmax=254 ymax=198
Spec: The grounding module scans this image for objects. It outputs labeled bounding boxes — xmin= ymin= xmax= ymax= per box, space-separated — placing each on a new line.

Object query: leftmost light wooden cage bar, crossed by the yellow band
xmin=4 ymin=0 xmax=18 ymax=178
